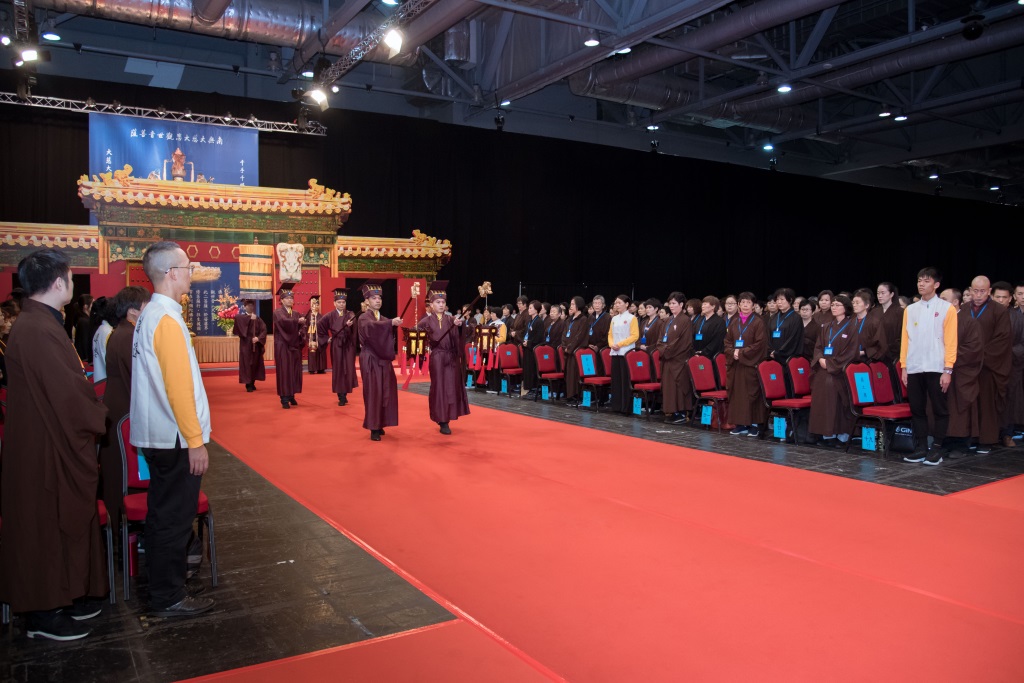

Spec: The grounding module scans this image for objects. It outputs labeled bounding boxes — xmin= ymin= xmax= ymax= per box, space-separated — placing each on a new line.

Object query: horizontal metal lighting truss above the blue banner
xmin=0 ymin=92 xmax=327 ymax=135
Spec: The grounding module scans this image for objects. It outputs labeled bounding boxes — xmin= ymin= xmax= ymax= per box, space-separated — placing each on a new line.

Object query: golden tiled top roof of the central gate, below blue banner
xmin=78 ymin=164 xmax=352 ymax=220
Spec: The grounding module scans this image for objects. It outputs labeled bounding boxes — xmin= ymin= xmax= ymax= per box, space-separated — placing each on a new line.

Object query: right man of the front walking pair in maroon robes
xmin=416 ymin=281 xmax=468 ymax=434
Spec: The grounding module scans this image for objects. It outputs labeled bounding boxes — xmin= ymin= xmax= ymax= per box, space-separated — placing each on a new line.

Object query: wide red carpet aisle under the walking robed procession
xmin=197 ymin=376 xmax=1024 ymax=682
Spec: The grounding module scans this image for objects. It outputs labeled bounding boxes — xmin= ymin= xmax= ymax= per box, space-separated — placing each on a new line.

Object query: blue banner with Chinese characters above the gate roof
xmin=89 ymin=114 xmax=259 ymax=185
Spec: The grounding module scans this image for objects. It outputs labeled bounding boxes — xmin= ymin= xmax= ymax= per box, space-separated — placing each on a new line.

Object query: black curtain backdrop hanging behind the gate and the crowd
xmin=0 ymin=73 xmax=1024 ymax=304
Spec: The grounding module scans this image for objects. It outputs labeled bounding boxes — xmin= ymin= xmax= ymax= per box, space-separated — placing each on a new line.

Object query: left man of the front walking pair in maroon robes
xmin=357 ymin=283 xmax=401 ymax=441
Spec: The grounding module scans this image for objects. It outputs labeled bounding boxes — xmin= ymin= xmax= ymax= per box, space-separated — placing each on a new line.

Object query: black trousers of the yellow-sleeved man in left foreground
xmin=142 ymin=440 xmax=203 ymax=609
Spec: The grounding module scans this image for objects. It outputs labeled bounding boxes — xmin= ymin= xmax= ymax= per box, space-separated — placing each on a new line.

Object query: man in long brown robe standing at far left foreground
xmin=0 ymin=249 xmax=108 ymax=640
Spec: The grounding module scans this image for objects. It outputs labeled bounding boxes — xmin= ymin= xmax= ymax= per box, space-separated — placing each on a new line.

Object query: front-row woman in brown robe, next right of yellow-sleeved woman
xmin=657 ymin=292 xmax=693 ymax=425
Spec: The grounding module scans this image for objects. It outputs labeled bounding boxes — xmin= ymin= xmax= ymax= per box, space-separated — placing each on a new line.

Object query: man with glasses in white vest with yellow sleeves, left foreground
xmin=131 ymin=242 xmax=213 ymax=616
